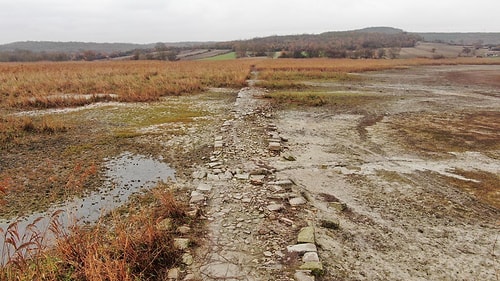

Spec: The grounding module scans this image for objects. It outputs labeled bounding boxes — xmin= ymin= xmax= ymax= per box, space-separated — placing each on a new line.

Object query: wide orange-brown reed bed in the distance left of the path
xmin=0 ymin=60 xmax=252 ymax=108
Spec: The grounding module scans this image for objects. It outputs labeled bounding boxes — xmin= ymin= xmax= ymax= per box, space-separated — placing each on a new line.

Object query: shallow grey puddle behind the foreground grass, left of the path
xmin=0 ymin=152 xmax=175 ymax=260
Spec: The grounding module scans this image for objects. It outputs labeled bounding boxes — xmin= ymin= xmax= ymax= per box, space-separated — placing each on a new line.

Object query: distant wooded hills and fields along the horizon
xmin=0 ymin=27 xmax=500 ymax=61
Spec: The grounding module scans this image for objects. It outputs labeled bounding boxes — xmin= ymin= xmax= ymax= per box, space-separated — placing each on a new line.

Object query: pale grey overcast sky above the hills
xmin=0 ymin=0 xmax=500 ymax=44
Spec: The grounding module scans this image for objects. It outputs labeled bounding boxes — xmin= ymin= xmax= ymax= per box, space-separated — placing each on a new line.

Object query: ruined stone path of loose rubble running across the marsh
xmin=184 ymin=73 xmax=322 ymax=281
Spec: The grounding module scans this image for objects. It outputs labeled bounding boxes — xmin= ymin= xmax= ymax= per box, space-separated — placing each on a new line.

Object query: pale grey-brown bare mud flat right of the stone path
xmin=274 ymin=66 xmax=500 ymax=280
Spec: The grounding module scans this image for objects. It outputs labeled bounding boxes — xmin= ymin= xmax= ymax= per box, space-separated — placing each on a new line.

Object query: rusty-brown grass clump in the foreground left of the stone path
xmin=0 ymin=185 xmax=189 ymax=280
